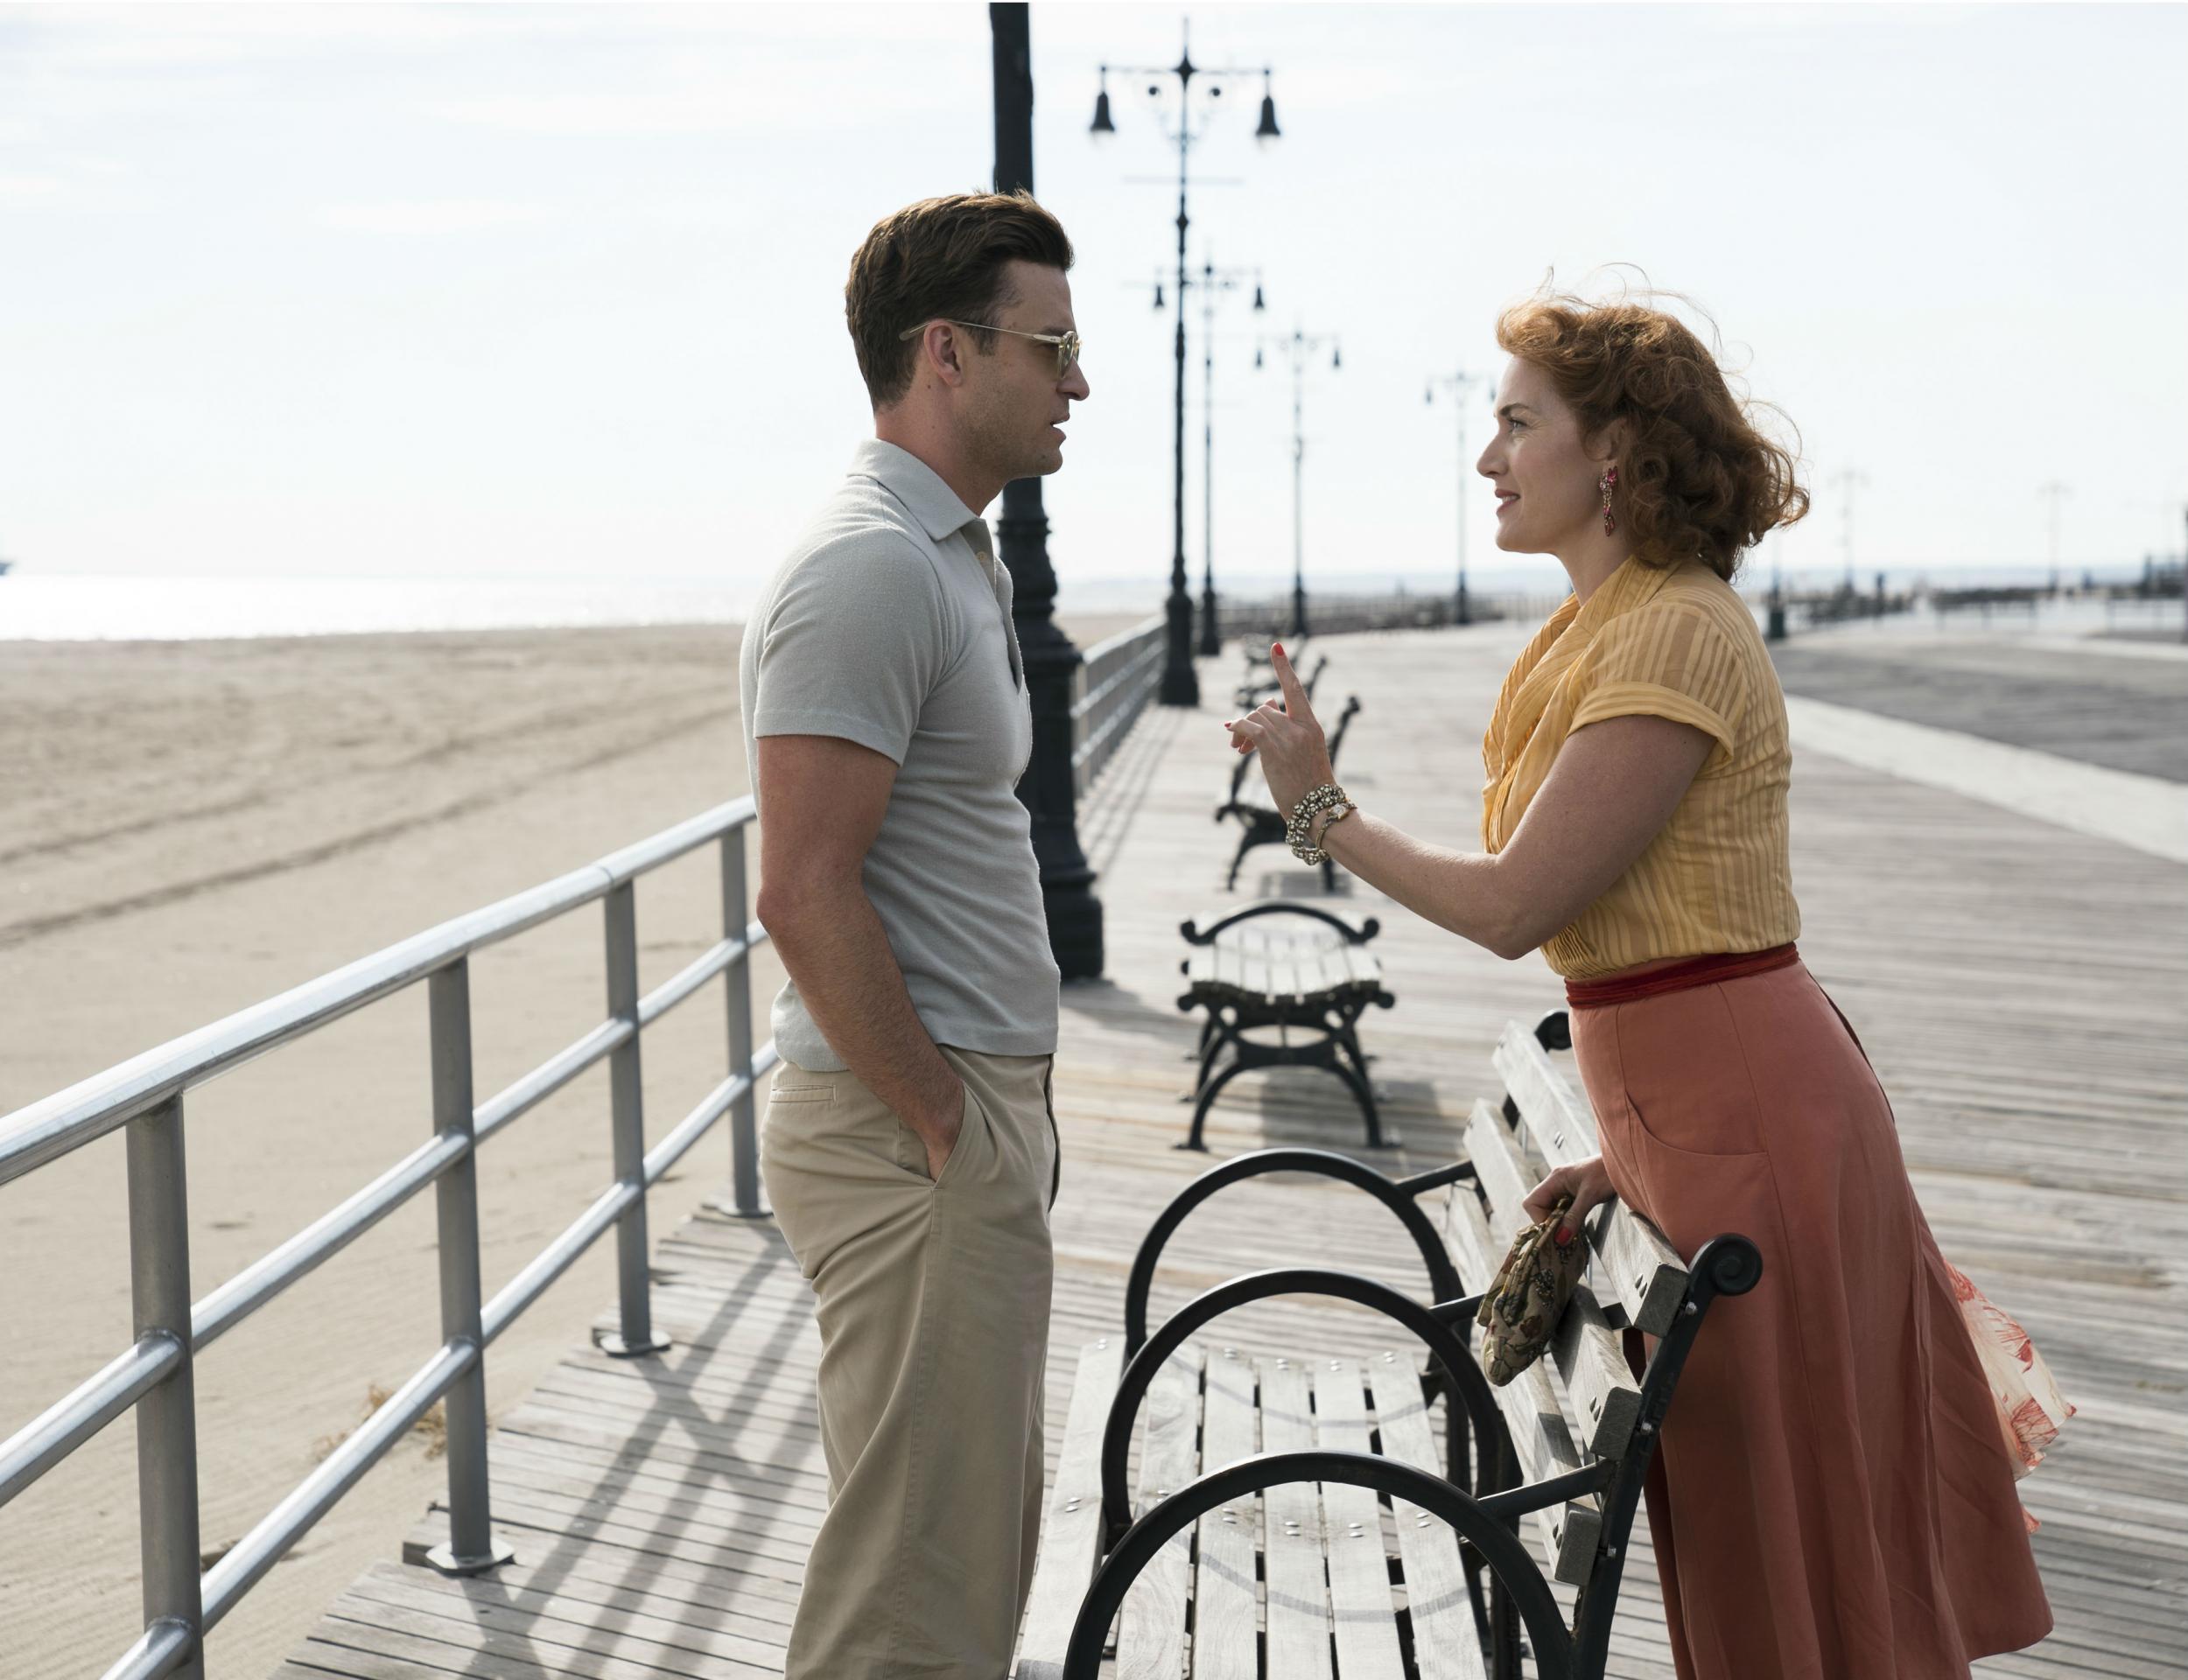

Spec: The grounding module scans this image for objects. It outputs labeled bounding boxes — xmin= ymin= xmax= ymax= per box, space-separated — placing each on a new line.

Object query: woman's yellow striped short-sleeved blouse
xmin=1482 ymin=560 xmax=1801 ymax=980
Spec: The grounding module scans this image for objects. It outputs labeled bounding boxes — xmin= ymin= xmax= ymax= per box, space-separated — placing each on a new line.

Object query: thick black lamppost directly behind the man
xmin=987 ymin=4 xmax=1103 ymax=980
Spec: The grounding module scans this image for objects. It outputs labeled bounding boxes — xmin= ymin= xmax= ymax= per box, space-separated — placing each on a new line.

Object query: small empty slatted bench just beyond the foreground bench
xmin=1177 ymin=900 xmax=1399 ymax=1149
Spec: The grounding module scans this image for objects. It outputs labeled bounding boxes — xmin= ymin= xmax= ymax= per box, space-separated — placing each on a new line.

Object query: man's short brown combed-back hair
xmin=843 ymin=191 xmax=1072 ymax=410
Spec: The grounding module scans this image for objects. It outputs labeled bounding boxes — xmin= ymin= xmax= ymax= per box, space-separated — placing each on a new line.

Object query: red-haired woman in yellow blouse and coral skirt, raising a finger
xmin=1228 ymin=298 xmax=2051 ymax=1680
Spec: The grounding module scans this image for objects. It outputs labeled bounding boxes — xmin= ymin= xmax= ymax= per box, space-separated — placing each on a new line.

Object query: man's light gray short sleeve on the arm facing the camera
xmin=753 ymin=532 xmax=945 ymax=766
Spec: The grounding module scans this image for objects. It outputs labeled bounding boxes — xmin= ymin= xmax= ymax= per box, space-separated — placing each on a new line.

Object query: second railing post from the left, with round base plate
xmin=424 ymin=956 xmax=516 ymax=1575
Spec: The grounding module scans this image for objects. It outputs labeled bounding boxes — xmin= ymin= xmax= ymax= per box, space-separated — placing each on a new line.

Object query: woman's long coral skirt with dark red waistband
xmin=1571 ymin=948 xmax=2052 ymax=1680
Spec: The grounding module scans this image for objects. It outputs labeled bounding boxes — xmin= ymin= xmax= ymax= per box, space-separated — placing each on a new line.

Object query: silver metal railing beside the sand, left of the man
xmin=0 ymin=799 xmax=777 ymax=1680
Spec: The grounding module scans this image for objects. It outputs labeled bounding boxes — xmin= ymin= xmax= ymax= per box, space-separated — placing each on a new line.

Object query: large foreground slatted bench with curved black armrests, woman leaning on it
xmin=1013 ymin=1013 xmax=1762 ymax=1680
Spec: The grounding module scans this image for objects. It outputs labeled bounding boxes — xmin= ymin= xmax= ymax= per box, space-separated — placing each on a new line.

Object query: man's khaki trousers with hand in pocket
xmin=760 ymin=1046 xmax=1057 ymax=1680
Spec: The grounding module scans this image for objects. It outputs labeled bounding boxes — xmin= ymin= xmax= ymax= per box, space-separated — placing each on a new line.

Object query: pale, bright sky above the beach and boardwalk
xmin=0 ymin=3 xmax=2188 ymax=599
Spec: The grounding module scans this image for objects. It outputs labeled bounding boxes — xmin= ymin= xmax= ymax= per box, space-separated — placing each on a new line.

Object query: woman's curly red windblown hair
xmin=1497 ymin=284 xmax=1807 ymax=582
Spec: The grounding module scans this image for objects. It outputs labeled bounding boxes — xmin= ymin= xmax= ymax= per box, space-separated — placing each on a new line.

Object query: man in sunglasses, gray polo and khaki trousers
xmin=740 ymin=192 xmax=1088 ymax=1680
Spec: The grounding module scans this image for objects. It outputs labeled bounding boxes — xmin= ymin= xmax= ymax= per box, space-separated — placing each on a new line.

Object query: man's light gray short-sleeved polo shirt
xmin=738 ymin=438 xmax=1057 ymax=1072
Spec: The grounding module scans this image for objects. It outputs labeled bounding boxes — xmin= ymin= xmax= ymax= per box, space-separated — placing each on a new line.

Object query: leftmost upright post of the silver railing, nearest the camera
xmin=127 ymin=1092 xmax=206 ymax=1680
